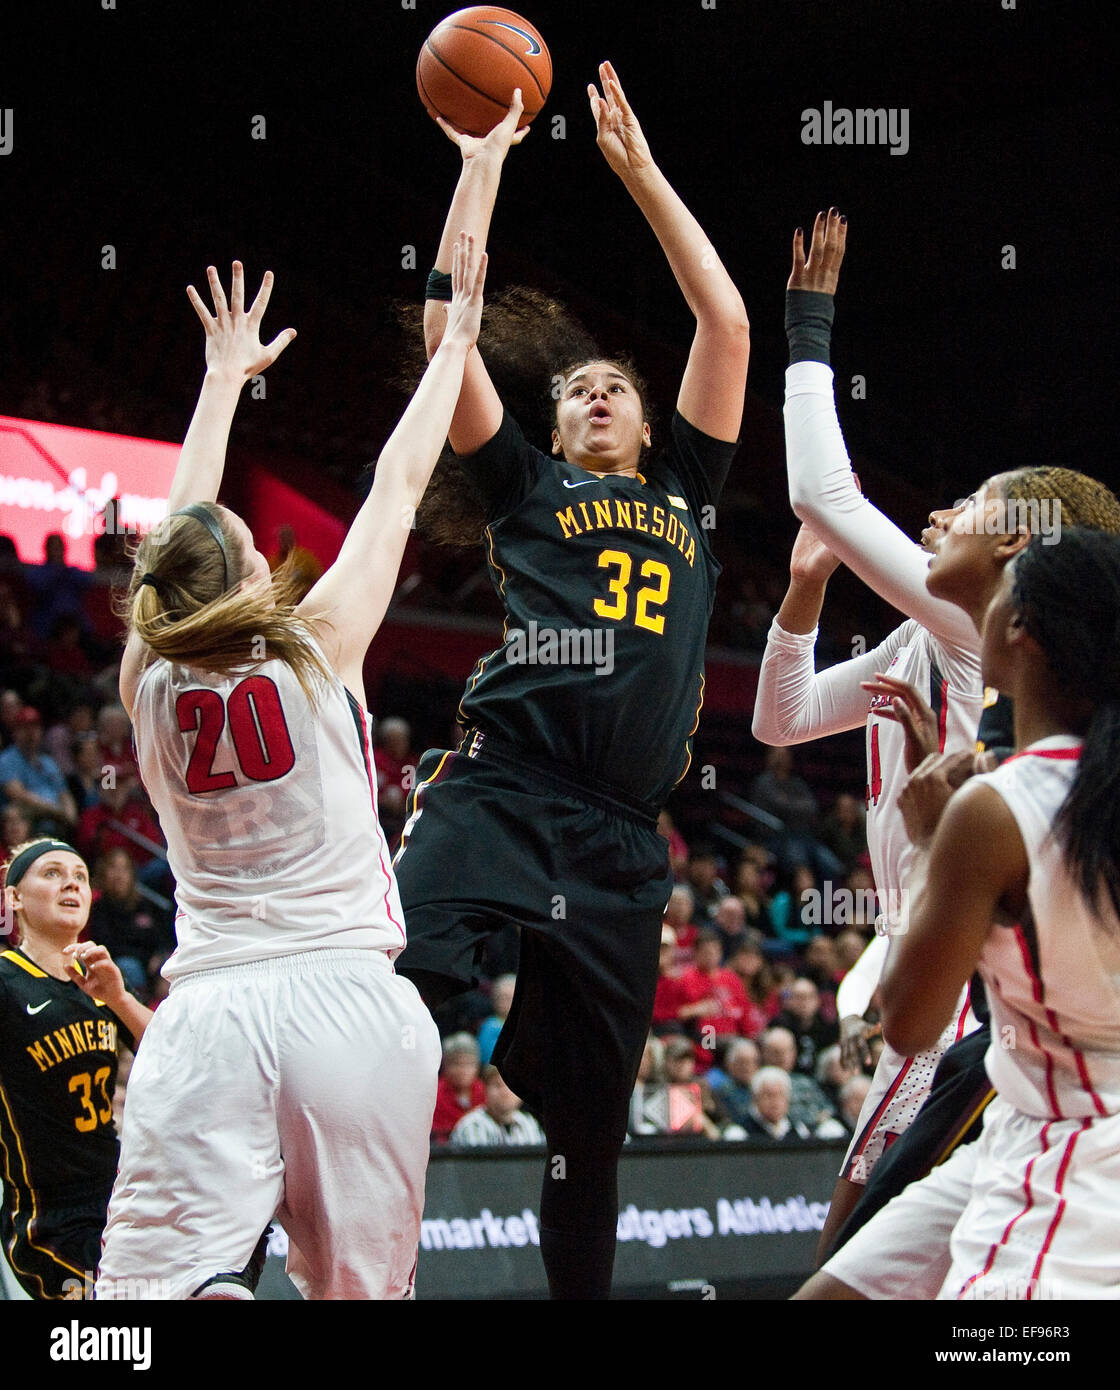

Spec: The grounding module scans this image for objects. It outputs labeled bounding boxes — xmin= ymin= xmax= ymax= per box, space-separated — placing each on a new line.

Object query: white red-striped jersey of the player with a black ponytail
xmin=980 ymin=737 xmax=1120 ymax=1119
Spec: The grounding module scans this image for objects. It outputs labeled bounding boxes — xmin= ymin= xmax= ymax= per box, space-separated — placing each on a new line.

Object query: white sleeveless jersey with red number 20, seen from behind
xmin=133 ymin=644 xmax=404 ymax=980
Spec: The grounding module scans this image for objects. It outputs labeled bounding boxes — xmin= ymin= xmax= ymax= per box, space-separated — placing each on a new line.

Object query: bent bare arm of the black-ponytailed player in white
xmin=880 ymin=753 xmax=1028 ymax=1056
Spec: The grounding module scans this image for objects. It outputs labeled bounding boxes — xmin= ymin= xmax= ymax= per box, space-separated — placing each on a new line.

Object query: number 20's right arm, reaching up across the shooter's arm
xmin=296 ymin=232 xmax=486 ymax=703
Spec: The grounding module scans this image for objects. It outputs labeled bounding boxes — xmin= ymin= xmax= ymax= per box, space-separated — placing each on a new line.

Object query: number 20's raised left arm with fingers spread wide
xmin=167 ymin=261 xmax=296 ymax=512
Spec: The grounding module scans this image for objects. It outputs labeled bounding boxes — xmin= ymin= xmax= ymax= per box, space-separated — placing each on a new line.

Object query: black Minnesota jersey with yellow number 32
xmin=460 ymin=413 xmax=736 ymax=806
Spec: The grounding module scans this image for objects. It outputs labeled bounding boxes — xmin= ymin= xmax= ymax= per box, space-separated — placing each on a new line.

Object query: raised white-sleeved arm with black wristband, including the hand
xmin=785 ymin=209 xmax=980 ymax=652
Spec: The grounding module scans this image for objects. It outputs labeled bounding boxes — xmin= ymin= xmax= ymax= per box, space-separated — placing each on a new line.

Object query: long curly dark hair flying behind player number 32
xmin=395 ymin=285 xmax=652 ymax=549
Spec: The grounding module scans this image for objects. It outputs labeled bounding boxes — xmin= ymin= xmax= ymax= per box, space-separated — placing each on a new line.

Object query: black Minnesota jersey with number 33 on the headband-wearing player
xmin=0 ymin=948 xmax=132 ymax=1215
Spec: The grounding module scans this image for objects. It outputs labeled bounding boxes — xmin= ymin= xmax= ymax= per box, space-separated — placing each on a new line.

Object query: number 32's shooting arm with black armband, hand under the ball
xmin=424 ymin=99 xmax=528 ymax=455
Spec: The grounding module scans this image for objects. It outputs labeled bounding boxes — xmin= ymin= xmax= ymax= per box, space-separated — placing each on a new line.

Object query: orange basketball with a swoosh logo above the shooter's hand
xmin=415 ymin=4 xmax=552 ymax=135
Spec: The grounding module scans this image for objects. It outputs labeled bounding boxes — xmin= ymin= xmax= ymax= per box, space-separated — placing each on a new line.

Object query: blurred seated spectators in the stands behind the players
xmin=0 ymin=532 xmax=877 ymax=1147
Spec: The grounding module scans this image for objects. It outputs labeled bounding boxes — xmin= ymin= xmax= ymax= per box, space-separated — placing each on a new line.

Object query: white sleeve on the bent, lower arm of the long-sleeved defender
xmin=750 ymin=619 xmax=909 ymax=746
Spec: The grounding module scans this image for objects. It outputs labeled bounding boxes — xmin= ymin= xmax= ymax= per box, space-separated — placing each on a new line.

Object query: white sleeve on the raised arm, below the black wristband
xmin=785 ymin=361 xmax=980 ymax=652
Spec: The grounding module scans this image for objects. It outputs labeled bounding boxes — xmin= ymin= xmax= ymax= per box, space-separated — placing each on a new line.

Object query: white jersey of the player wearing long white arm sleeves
xmin=866 ymin=619 xmax=984 ymax=919
